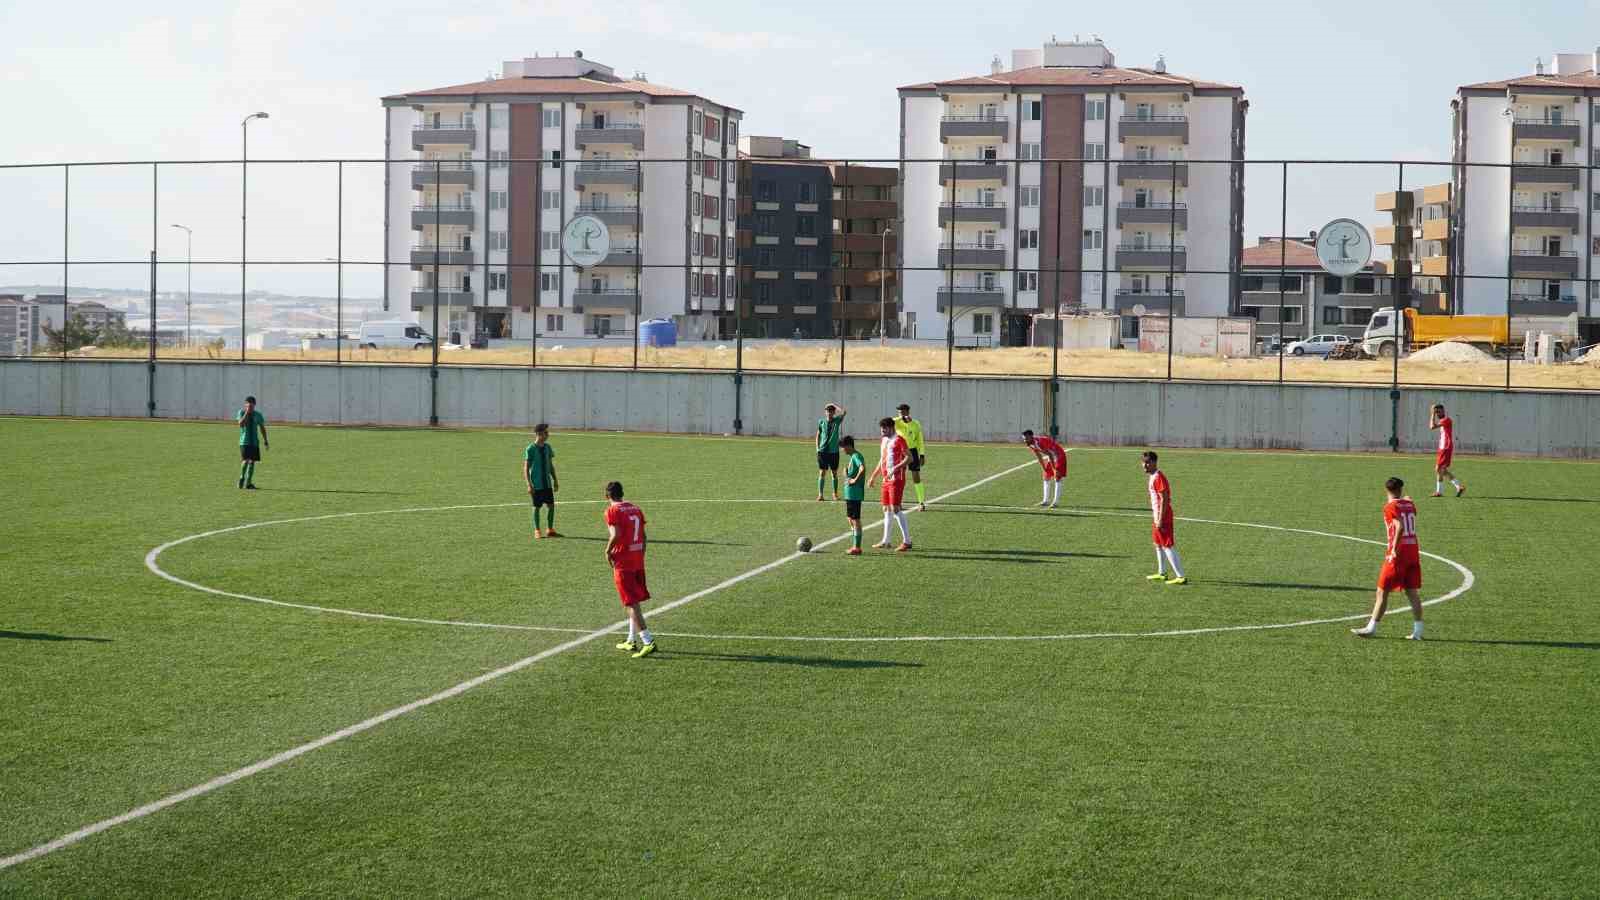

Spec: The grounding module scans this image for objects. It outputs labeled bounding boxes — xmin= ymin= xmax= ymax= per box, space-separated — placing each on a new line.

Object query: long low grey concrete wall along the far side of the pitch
xmin=0 ymin=360 xmax=1600 ymax=458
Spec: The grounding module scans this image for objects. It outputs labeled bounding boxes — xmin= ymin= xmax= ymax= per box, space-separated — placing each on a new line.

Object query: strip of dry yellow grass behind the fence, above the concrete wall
xmin=34 ymin=341 xmax=1600 ymax=389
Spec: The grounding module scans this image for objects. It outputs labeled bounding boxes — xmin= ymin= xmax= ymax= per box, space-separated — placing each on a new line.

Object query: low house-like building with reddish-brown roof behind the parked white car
xmin=1238 ymin=232 xmax=1392 ymax=341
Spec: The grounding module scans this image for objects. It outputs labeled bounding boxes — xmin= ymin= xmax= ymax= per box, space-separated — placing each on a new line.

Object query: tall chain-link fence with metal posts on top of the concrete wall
xmin=0 ymin=155 xmax=1600 ymax=389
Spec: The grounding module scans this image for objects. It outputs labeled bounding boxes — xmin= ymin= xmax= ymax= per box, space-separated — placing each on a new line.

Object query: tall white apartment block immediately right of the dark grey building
xmin=898 ymin=38 xmax=1248 ymax=344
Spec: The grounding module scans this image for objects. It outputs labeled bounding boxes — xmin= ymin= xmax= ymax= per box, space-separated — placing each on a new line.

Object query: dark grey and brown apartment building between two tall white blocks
xmin=739 ymin=136 xmax=899 ymax=338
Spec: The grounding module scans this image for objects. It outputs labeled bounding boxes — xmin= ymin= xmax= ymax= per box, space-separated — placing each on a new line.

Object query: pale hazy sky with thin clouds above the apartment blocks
xmin=0 ymin=0 xmax=1600 ymax=295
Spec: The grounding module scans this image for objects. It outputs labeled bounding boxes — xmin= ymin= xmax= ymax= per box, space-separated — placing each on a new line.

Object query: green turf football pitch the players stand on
xmin=0 ymin=410 xmax=1600 ymax=897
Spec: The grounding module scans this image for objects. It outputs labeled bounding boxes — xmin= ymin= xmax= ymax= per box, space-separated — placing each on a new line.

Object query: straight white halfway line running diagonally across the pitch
xmin=0 ymin=460 xmax=1037 ymax=870
